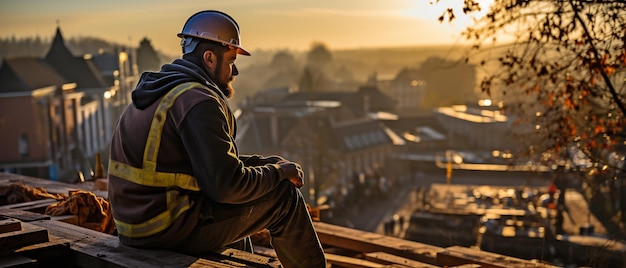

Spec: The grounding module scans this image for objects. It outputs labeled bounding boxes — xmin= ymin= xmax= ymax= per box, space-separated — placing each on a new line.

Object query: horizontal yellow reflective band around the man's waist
xmin=109 ymin=160 xmax=200 ymax=191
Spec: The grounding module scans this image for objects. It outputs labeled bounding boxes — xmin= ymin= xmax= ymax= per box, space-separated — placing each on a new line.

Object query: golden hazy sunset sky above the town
xmin=0 ymin=0 xmax=488 ymax=55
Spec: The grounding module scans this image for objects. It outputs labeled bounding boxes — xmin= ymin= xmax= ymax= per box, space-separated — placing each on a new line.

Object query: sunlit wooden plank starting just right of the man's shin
xmin=313 ymin=222 xmax=444 ymax=265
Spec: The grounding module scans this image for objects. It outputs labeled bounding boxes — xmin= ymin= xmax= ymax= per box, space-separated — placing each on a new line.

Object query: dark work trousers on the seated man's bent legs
xmin=176 ymin=180 xmax=326 ymax=268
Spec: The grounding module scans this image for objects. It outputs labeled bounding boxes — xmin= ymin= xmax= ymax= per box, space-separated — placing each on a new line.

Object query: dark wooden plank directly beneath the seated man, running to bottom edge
xmin=25 ymin=220 xmax=254 ymax=267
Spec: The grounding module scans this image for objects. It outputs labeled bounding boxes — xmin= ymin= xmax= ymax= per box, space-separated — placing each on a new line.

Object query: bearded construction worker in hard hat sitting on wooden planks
xmin=108 ymin=10 xmax=326 ymax=267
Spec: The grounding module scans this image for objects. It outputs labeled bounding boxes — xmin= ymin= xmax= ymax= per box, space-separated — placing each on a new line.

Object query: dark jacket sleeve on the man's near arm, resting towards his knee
xmin=179 ymin=96 xmax=284 ymax=204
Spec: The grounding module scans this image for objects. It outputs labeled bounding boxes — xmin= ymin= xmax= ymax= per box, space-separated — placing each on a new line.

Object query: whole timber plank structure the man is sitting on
xmin=0 ymin=173 xmax=557 ymax=268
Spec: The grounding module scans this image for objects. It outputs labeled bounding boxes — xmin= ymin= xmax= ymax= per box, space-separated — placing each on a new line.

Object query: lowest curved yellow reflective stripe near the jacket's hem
xmin=114 ymin=191 xmax=192 ymax=238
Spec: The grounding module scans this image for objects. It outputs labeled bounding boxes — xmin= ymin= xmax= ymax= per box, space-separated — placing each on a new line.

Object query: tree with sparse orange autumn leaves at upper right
xmin=439 ymin=0 xmax=626 ymax=168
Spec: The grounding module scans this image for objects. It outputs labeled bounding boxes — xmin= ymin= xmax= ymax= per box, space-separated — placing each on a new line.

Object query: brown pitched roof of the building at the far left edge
xmin=0 ymin=57 xmax=68 ymax=93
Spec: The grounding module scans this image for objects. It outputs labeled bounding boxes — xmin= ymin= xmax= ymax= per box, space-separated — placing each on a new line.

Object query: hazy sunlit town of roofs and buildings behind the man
xmin=0 ymin=28 xmax=613 ymax=263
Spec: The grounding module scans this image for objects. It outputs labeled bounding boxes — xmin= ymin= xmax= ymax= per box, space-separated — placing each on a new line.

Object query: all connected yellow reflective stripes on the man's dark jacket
xmin=109 ymin=82 xmax=202 ymax=238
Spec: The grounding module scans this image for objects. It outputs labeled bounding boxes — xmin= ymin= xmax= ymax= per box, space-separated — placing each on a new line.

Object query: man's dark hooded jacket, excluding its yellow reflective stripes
xmin=108 ymin=59 xmax=284 ymax=248
